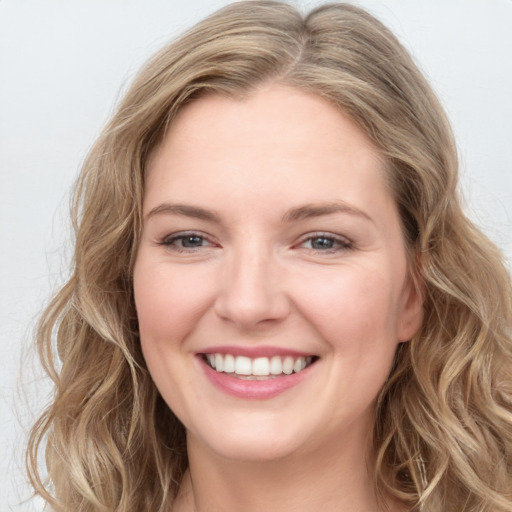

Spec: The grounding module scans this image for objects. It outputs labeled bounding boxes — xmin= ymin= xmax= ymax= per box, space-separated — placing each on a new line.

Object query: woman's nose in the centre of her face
xmin=215 ymin=247 xmax=290 ymax=331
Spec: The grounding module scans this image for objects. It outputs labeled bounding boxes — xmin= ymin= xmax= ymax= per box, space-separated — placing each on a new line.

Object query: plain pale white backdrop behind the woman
xmin=0 ymin=0 xmax=512 ymax=511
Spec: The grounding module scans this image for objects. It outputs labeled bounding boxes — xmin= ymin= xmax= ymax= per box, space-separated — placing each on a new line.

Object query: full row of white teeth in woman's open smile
xmin=206 ymin=354 xmax=312 ymax=380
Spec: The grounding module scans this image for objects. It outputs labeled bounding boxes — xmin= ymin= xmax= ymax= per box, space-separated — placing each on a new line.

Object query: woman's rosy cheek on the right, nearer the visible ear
xmin=303 ymin=267 xmax=406 ymax=406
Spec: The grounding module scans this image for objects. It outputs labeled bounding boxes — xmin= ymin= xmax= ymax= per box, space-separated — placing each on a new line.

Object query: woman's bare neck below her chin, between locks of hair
xmin=173 ymin=426 xmax=388 ymax=512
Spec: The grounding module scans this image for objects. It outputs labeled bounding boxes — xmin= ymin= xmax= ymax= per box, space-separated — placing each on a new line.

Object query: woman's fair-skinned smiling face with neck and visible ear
xmin=134 ymin=84 xmax=421 ymax=512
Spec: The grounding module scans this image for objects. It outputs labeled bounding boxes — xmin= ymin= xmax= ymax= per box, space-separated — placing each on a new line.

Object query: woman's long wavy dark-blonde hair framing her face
xmin=27 ymin=0 xmax=512 ymax=512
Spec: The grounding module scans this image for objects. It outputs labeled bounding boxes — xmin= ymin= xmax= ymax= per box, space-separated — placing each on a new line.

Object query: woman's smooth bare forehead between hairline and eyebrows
xmin=146 ymin=85 xmax=389 ymax=220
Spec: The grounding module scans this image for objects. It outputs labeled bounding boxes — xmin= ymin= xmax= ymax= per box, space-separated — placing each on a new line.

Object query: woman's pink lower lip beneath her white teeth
xmin=199 ymin=357 xmax=314 ymax=400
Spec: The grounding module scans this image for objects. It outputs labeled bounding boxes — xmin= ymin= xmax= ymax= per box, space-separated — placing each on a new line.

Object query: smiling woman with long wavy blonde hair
xmin=28 ymin=1 xmax=512 ymax=512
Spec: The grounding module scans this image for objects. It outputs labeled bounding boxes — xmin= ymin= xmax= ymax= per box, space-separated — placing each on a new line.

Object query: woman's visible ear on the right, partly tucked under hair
xmin=397 ymin=271 xmax=425 ymax=342
